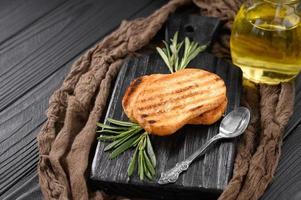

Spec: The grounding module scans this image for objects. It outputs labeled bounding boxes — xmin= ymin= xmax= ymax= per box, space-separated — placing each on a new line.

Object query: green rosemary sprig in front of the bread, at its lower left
xmin=97 ymin=118 xmax=156 ymax=180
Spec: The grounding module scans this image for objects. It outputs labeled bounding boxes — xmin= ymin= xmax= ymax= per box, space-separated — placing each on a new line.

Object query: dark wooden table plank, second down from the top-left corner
xmin=0 ymin=0 xmax=164 ymax=111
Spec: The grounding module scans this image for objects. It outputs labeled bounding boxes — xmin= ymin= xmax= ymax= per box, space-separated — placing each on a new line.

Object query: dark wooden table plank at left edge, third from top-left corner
xmin=0 ymin=63 xmax=68 ymax=194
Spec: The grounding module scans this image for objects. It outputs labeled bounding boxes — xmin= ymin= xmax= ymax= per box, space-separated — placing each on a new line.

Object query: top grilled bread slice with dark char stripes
xmin=132 ymin=69 xmax=226 ymax=135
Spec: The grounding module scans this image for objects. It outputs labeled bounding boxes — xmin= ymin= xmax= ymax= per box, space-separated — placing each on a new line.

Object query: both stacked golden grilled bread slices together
xmin=122 ymin=69 xmax=227 ymax=135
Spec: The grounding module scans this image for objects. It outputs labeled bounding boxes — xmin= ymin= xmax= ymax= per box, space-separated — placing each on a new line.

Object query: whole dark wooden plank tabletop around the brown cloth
xmin=0 ymin=0 xmax=301 ymax=200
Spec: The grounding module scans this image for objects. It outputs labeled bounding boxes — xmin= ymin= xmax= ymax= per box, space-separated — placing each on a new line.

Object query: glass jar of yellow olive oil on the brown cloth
xmin=230 ymin=0 xmax=301 ymax=84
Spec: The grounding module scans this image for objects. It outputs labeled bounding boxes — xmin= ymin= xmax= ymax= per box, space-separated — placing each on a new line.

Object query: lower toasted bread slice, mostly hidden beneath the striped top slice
xmin=122 ymin=74 xmax=227 ymax=125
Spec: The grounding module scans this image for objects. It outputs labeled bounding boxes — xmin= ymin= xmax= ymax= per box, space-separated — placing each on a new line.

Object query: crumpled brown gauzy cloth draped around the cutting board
xmin=38 ymin=0 xmax=294 ymax=200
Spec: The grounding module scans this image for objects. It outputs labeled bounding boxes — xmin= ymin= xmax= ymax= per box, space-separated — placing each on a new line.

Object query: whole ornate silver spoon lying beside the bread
xmin=158 ymin=107 xmax=250 ymax=184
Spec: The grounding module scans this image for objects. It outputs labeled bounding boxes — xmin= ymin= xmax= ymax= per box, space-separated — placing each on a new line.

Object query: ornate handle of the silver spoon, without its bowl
xmin=158 ymin=134 xmax=222 ymax=184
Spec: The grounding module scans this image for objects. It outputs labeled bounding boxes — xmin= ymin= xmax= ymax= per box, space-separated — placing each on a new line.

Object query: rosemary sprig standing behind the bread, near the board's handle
xmin=156 ymin=32 xmax=207 ymax=73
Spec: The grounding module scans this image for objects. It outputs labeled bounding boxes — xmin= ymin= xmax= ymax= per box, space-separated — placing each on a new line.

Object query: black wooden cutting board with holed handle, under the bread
xmin=91 ymin=16 xmax=241 ymax=199
